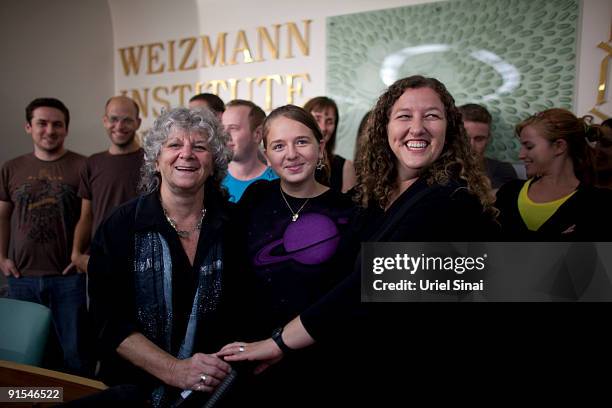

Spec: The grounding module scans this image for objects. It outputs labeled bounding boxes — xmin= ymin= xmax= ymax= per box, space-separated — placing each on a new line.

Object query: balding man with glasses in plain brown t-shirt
xmin=71 ymin=96 xmax=143 ymax=272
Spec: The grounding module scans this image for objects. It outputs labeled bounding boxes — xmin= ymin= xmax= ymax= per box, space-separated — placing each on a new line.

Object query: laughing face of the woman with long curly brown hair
xmin=387 ymin=88 xmax=447 ymax=182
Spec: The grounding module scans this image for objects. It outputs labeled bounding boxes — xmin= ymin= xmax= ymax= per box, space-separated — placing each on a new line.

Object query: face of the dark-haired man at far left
xmin=25 ymin=106 xmax=68 ymax=155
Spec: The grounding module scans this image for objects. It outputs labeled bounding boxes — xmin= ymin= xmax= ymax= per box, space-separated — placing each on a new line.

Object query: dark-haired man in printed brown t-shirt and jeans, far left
xmin=0 ymin=98 xmax=88 ymax=375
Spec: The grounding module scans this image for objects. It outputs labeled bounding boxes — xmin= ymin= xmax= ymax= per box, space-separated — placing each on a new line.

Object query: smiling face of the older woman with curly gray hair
xmin=156 ymin=128 xmax=213 ymax=197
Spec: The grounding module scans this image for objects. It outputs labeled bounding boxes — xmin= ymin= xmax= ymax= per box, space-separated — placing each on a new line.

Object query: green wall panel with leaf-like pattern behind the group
xmin=327 ymin=0 xmax=580 ymax=162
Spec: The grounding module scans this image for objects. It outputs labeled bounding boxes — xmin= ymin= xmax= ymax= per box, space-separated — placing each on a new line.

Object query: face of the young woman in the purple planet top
xmin=266 ymin=116 xmax=324 ymax=189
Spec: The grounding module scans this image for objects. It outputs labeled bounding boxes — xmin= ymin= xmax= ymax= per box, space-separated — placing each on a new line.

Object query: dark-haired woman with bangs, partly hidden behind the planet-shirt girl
xmin=304 ymin=96 xmax=355 ymax=193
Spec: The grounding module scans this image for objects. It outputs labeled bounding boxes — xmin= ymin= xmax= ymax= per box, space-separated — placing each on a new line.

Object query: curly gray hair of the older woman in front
xmin=139 ymin=108 xmax=232 ymax=195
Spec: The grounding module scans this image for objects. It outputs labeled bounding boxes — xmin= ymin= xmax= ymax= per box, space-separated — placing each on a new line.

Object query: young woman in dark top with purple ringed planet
xmin=222 ymin=105 xmax=355 ymax=406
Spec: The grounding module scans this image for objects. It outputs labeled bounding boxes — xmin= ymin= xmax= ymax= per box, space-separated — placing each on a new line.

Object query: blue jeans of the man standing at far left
xmin=8 ymin=273 xmax=91 ymax=376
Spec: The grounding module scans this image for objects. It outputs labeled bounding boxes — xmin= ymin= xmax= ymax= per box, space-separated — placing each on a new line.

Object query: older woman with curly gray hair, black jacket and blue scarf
xmin=89 ymin=108 xmax=240 ymax=406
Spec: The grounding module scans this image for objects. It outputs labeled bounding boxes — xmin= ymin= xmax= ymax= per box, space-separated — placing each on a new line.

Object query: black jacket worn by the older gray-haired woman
xmin=88 ymin=188 xmax=242 ymax=396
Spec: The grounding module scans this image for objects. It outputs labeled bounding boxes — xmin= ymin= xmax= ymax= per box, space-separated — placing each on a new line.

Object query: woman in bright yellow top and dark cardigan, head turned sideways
xmin=496 ymin=109 xmax=612 ymax=241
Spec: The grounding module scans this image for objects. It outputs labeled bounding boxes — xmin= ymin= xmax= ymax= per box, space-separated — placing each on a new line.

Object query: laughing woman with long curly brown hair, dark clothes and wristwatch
xmin=221 ymin=76 xmax=497 ymax=397
